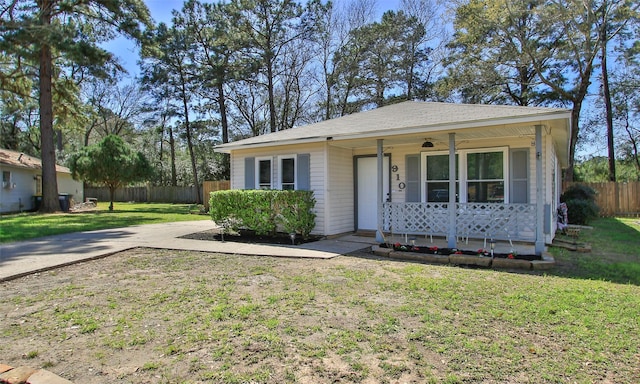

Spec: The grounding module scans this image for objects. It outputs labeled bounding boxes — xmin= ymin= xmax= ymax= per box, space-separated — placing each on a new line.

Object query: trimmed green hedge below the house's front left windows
xmin=209 ymin=189 xmax=316 ymax=238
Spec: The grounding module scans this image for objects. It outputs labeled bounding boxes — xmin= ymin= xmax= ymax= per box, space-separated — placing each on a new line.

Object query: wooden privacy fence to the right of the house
xmin=562 ymin=181 xmax=640 ymax=217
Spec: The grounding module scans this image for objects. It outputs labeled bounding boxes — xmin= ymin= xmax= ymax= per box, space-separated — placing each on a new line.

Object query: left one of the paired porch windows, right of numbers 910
xmin=424 ymin=153 xmax=460 ymax=203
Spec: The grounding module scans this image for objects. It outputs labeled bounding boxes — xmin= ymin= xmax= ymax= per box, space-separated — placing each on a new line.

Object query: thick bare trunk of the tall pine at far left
xmin=38 ymin=0 xmax=60 ymax=213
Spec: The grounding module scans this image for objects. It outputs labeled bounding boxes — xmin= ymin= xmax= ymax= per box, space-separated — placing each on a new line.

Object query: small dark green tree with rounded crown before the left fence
xmin=69 ymin=135 xmax=153 ymax=211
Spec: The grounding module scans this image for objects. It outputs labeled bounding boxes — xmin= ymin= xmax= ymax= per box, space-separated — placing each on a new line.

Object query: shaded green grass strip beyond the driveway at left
xmin=0 ymin=202 xmax=211 ymax=243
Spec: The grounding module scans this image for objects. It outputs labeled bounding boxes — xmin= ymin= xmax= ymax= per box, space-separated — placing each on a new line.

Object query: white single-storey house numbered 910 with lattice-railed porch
xmin=215 ymin=101 xmax=570 ymax=253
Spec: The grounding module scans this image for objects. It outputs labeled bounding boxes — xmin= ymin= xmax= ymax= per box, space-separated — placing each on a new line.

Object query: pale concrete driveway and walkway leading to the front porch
xmin=0 ymin=220 xmax=375 ymax=282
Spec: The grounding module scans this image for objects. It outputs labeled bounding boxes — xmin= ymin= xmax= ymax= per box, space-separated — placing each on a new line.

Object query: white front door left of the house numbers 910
xmin=356 ymin=156 xmax=390 ymax=230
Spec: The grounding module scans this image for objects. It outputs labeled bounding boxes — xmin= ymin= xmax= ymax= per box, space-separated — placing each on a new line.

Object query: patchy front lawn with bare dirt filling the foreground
xmin=0 ymin=249 xmax=640 ymax=384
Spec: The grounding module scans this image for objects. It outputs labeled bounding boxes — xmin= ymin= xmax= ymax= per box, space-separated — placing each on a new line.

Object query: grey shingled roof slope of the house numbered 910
xmin=216 ymin=101 xmax=570 ymax=152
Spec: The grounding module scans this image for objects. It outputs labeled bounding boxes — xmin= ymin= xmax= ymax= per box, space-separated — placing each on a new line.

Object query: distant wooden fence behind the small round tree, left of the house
xmin=84 ymin=180 xmax=229 ymax=209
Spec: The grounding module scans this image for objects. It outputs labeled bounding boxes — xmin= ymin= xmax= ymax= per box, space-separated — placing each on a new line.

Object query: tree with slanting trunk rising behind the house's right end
xmin=442 ymin=0 xmax=624 ymax=181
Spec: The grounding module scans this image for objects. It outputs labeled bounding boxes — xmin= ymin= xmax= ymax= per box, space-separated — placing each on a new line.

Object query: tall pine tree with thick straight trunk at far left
xmin=0 ymin=0 xmax=150 ymax=212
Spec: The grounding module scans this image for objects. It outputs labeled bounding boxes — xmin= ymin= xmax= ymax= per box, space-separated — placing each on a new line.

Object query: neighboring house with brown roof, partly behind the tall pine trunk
xmin=0 ymin=149 xmax=84 ymax=213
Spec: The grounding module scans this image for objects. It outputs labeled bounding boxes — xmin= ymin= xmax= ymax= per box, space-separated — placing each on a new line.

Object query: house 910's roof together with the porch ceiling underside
xmin=215 ymin=101 xmax=571 ymax=162
